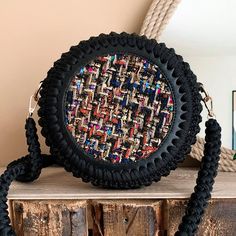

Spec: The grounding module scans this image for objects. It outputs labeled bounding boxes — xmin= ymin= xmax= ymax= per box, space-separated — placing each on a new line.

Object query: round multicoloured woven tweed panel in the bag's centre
xmin=65 ymin=54 xmax=174 ymax=163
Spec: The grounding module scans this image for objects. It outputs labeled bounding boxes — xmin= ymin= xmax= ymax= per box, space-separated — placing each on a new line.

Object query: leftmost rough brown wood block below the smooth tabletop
xmin=12 ymin=200 xmax=88 ymax=236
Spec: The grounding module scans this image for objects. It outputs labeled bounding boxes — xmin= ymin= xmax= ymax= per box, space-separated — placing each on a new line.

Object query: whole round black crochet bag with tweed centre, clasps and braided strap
xmin=0 ymin=32 xmax=221 ymax=235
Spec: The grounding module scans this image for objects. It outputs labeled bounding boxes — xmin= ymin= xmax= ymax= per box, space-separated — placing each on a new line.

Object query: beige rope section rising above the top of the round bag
xmin=140 ymin=0 xmax=180 ymax=39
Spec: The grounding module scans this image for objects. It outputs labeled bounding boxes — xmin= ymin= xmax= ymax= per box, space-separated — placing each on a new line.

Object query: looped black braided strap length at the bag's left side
xmin=0 ymin=117 xmax=56 ymax=236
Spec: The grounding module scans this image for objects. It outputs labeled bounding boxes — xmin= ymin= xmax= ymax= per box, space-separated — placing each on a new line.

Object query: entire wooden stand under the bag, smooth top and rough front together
xmin=0 ymin=167 xmax=236 ymax=236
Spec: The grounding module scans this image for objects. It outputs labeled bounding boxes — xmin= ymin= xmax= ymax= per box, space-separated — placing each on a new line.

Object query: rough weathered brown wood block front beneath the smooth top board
xmin=9 ymin=199 xmax=236 ymax=236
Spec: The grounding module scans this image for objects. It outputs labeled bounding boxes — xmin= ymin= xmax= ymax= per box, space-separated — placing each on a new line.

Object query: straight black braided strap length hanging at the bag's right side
xmin=175 ymin=119 xmax=221 ymax=236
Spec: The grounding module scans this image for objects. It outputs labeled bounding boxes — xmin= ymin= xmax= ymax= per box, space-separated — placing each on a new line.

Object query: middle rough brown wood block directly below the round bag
xmin=92 ymin=200 xmax=163 ymax=236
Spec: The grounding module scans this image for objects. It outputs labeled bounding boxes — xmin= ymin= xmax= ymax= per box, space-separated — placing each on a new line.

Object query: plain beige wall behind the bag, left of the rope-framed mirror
xmin=0 ymin=0 xmax=151 ymax=166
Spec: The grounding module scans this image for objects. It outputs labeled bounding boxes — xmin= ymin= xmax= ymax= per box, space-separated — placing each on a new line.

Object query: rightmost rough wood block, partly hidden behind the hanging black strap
xmin=166 ymin=199 xmax=236 ymax=236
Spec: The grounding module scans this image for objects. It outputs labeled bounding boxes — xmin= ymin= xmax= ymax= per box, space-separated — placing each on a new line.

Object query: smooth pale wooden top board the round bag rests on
xmin=0 ymin=167 xmax=236 ymax=200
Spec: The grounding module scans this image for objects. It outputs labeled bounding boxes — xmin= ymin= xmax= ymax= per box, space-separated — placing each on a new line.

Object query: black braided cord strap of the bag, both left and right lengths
xmin=0 ymin=117 xmax=221 ymax=236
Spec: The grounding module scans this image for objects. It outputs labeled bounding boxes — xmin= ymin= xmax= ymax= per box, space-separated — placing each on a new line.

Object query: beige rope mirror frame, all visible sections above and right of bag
xmin=140 ymin=0 xmax=236 ymax=172
